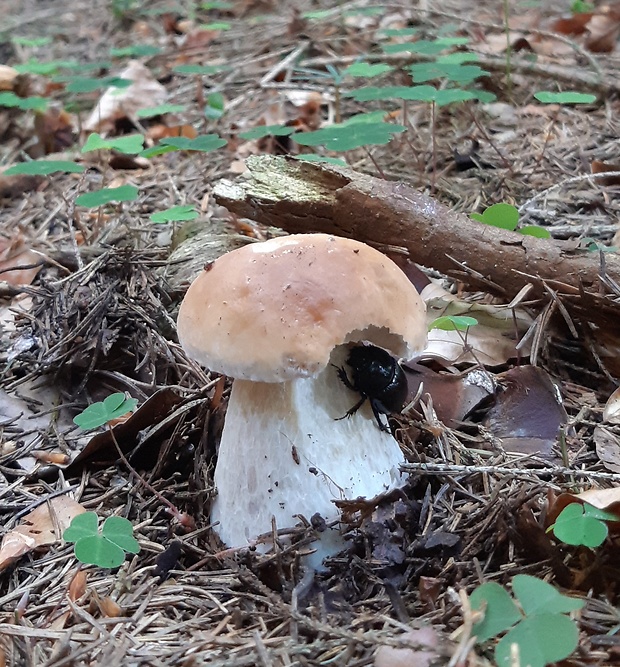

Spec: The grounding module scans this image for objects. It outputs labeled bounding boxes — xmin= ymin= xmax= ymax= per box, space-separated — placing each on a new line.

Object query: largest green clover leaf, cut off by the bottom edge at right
xmin=471 ymin=574 xmax=584 ymax=667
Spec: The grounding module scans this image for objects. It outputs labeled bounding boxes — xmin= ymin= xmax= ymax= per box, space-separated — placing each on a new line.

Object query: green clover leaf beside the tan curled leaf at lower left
xmin=62 ymin=512 xmax=140 ymax=568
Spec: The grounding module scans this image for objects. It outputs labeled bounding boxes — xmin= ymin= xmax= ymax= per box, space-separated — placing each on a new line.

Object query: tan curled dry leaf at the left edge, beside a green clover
xmin=0 ymin=496 xmax=86 ymax=570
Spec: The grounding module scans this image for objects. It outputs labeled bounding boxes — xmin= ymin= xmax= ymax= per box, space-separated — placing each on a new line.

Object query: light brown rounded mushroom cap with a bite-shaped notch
xmin=177 ymin=234 xmax=426 ymax=382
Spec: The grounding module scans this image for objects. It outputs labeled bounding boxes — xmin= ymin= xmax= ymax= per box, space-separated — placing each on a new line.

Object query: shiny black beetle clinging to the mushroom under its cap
xmin=336 ymin=345 xmax=408 ymax=432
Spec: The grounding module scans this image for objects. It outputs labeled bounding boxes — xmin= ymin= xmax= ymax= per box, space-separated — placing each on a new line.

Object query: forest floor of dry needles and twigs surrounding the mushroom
xmin=0 ymin=0 xmax=620 ymax=667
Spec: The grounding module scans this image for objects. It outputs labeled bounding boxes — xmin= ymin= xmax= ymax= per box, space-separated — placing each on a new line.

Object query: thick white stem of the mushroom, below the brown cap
xmin=211 ymin=347 xmax=403 ymax=562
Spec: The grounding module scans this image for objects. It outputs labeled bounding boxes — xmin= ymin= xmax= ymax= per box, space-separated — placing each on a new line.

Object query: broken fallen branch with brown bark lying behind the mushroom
xmin=214 ymin=155 xmax=620 ymax=319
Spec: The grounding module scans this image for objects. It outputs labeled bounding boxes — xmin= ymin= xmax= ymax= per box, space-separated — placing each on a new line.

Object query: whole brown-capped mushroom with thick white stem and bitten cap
xmin=177 ymin=234 xmax=426 ymax=564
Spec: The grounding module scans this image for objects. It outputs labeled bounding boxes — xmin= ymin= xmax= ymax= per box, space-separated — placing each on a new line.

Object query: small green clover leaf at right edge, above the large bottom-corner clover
xmin=547 ymin=503 xmax=618 ymax=548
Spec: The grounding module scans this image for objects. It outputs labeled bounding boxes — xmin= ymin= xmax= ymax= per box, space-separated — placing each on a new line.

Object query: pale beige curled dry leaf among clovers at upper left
xmin=84 ymin=60 xmax=167 ymax=133
